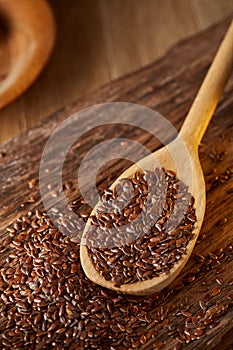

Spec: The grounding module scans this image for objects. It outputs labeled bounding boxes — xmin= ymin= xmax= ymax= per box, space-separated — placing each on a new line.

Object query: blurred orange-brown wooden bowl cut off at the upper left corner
xmin=0 ymin=0 xmax=55 ymax=109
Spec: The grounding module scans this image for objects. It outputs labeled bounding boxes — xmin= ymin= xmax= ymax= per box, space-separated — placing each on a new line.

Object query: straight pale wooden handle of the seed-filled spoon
xmin=180 ymin=21 xmax=233 ymax=152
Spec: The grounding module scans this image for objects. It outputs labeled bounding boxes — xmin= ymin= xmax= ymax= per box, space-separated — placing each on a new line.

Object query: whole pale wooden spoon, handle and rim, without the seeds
xmin=80 ymin=22 xmax=233 ymax=295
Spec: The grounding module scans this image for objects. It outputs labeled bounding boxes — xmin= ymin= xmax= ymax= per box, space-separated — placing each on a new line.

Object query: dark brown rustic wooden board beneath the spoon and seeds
xmin=0 ymin=19 xmax=233 ymax=349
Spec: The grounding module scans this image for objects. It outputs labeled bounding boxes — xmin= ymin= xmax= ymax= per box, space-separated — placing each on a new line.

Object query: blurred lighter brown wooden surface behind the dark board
xmin=0 ymin=0 xmax=233 ymax=143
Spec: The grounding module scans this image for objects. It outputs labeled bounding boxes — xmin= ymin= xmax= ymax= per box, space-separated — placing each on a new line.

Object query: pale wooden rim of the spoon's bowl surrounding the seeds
xmin=80 ymin=136 xmax=205 ymax=295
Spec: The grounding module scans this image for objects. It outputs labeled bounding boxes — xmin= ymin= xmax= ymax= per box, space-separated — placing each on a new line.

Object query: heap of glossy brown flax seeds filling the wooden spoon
xmin=86 ymin=168 xmax=196 ymax=287
